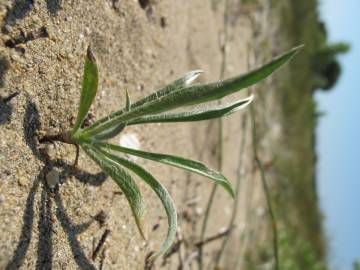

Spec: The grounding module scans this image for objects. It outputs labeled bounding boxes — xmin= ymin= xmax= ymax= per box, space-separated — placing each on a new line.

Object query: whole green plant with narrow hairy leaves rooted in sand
xmin=40 ymin=47 xmax=301 ymax=260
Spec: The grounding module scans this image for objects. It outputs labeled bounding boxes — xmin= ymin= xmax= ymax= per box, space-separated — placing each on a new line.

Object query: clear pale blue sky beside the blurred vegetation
xmin=316 ymin=0 xmax=360 ymax=270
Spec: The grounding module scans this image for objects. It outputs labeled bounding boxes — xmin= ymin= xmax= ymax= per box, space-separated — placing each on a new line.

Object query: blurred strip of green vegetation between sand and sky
xmin=273 ymin=0 xmax=350 ymax=269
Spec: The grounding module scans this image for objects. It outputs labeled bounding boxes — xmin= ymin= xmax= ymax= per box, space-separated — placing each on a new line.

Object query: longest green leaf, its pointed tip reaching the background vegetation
xmin=84 ymin=46 xmax=302 ymax=136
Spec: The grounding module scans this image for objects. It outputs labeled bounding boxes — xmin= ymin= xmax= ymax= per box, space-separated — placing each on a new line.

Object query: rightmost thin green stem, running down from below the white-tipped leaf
xmin=250 ymin=105 xmax=279 ymax=270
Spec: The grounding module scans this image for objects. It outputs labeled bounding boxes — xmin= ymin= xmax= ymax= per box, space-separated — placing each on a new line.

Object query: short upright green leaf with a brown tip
xmin=72 ymin=46 xmax=99 ymax=134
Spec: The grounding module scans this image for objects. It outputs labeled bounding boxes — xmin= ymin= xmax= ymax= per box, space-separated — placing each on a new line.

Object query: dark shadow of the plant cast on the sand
xmin=5 ymin=100 xmax=107 ymax=270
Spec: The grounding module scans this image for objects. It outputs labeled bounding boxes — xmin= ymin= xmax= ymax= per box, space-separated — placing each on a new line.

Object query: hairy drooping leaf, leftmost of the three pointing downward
xmin=81 ymin=144 xmax=145 ymax=238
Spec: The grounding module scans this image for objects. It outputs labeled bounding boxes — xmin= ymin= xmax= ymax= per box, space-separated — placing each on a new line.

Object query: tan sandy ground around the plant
xmin=0 ymin=0 xmax=282 ymax=269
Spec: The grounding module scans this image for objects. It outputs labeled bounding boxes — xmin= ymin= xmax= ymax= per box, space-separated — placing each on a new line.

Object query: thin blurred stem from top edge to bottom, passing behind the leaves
xmin=198 ymin=0 xmax=229 ymax=270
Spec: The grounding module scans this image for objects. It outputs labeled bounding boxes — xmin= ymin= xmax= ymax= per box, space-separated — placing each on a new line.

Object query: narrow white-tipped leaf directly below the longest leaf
xmin=127 ymin=96 xmax=253 ymax=125
